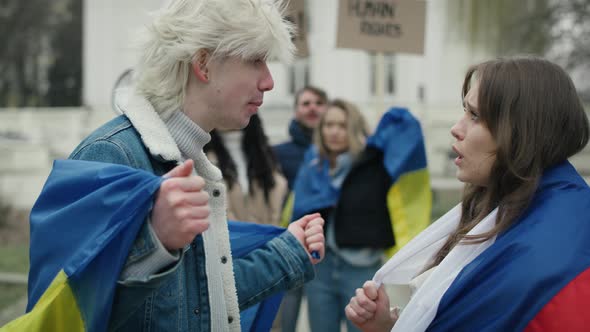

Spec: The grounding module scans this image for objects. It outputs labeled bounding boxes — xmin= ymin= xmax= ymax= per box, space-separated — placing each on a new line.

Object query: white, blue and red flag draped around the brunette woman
xmin=374 ymin=162 xmax=590 ymax=332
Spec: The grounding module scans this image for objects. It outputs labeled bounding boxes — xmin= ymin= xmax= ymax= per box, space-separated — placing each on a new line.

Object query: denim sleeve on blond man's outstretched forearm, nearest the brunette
xmin=234 ymin=231 xmax=315 ymax=310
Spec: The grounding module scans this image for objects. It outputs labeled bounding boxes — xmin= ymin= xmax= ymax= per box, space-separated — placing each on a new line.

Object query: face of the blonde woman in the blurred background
xmin=321 ymin=106 xmax=348 ymax=154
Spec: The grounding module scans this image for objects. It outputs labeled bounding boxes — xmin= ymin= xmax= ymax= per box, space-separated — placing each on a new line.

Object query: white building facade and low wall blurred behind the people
xmin=0 ymin=0 xmax=590 ymax=208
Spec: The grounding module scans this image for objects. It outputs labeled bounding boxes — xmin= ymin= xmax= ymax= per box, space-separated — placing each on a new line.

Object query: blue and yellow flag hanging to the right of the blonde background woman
xmin=367 ymin=107 xmax=432 ymax=256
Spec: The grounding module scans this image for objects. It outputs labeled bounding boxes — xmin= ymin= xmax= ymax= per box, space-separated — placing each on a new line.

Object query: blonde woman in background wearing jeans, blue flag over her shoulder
xmin=293 ymin=99 xmax=374 ymax=332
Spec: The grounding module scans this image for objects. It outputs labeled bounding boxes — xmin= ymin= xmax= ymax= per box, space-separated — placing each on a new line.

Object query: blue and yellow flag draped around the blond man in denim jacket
xmin=0 ymin=160 xmax=284 ymax=332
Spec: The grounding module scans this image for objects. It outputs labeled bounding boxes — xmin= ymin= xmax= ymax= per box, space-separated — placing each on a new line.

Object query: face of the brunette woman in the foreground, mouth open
xmin=451 ymin=82 xmax=497 ymax=187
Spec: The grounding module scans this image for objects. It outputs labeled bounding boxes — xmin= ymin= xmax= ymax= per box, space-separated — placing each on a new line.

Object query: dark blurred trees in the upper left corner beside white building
xmin=0 ymin=0 xmax=82 ymax=107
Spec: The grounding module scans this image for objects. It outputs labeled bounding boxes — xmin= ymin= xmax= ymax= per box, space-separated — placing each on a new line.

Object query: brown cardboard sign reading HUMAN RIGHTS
xmin=336 ymin=0 xmax=426 ymax=54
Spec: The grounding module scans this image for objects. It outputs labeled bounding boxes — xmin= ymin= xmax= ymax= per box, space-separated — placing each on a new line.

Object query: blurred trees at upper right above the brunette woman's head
xmin=446 ymin=0 xmax=590 ymax=71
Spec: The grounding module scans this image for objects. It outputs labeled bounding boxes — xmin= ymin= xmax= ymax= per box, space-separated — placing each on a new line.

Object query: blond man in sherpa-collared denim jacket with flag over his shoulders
xmin=7 ymin=0 xmax=324 ymax=331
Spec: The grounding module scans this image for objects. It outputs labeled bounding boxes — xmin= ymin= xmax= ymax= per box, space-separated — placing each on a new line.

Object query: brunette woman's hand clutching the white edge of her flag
xmin=344 ymin=280 xmax=399 ymax=332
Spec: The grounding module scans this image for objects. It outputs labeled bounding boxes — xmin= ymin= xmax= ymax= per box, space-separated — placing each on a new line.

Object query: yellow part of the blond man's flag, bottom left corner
xmin=0 ymin=270 xmax=84 ymax=332
